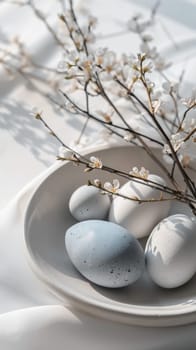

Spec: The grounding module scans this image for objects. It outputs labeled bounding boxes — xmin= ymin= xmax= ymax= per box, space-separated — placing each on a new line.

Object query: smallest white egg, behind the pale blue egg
xmin=69 ymin=185 xmax=111 ymax=221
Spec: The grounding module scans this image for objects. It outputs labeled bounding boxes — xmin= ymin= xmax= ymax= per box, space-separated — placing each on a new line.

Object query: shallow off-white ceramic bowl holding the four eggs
xmin=25 ymin=147 xmax=196 ymax=326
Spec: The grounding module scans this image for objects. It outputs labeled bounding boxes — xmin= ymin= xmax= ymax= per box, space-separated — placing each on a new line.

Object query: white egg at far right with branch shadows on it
xmin=145 ymin=214 xmax=196 ymax=288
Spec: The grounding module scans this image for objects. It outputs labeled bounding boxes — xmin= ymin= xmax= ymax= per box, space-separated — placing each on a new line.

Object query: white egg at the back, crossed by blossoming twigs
xmin=109 ymin=174 xmax=170 ymax=238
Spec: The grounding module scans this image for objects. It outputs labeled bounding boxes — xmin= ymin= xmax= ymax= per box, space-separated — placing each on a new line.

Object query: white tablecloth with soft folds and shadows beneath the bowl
xmin=0 ymin=0 xmax=196 ymax=350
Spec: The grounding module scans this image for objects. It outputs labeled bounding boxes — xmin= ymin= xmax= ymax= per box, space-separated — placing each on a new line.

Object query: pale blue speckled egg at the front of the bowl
xmin=65 ymin=220 xmax=144 ymax=288
